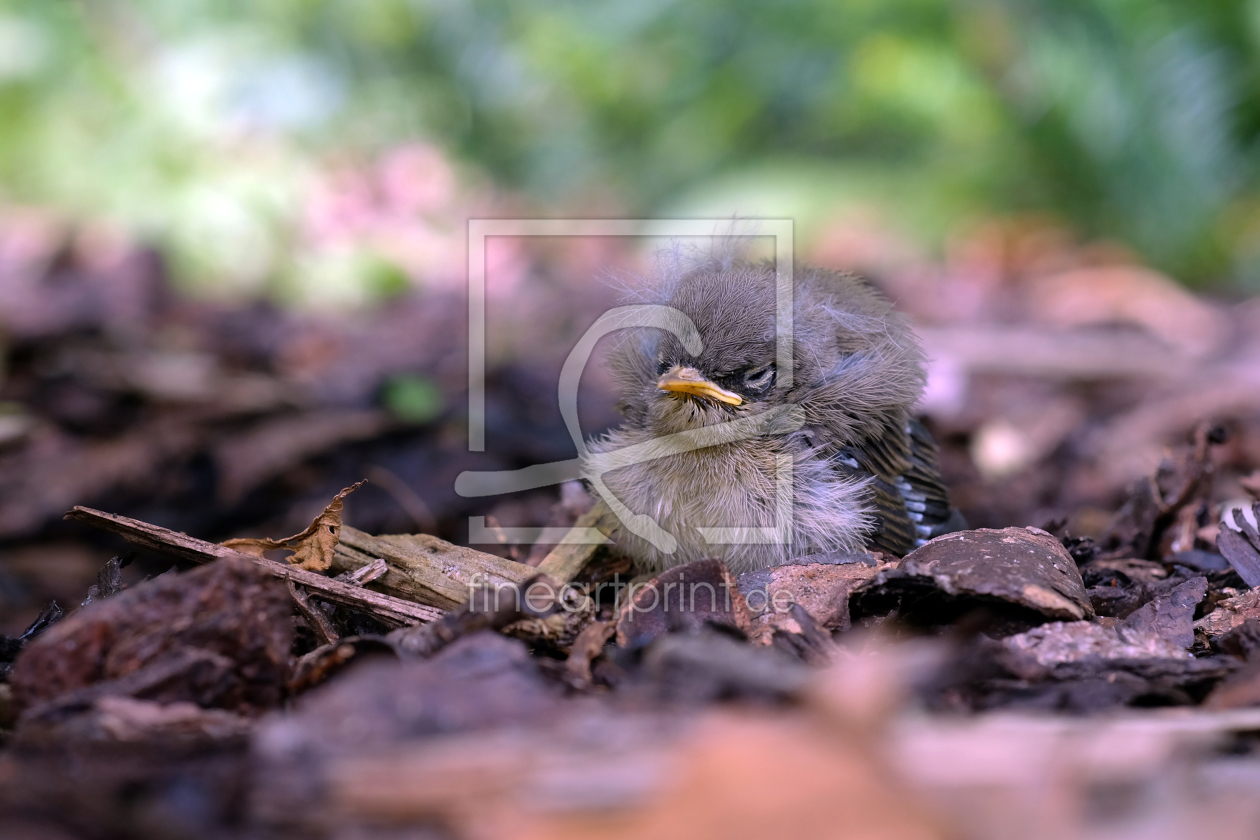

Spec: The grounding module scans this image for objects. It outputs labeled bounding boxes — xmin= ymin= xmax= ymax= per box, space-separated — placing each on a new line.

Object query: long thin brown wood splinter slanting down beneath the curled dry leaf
xmin=66 ymin=506 xmax=442 ymax=627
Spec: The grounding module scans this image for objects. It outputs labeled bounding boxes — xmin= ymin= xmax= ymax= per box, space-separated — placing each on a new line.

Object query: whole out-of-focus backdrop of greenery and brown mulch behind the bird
xmin=0 ymin=0 xmax=1260 ymax=632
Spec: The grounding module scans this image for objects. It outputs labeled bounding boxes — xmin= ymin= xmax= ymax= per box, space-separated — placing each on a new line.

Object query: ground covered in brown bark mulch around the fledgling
xmin=0 ymin=224 xmax=1260 ymax=837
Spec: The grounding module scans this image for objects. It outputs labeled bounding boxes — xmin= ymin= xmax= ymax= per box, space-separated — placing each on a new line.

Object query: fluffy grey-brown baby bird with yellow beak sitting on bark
xmin=588 ymin=259 xmax=966 ymax=573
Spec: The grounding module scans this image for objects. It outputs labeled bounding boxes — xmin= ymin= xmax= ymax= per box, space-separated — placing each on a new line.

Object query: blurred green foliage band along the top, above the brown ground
xmin=0 ymin=0 xmax=1260 ymax=285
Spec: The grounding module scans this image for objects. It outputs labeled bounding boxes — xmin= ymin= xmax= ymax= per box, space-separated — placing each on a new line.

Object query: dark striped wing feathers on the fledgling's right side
xmin=834 ymin=421 xmax=965 ymax=557
